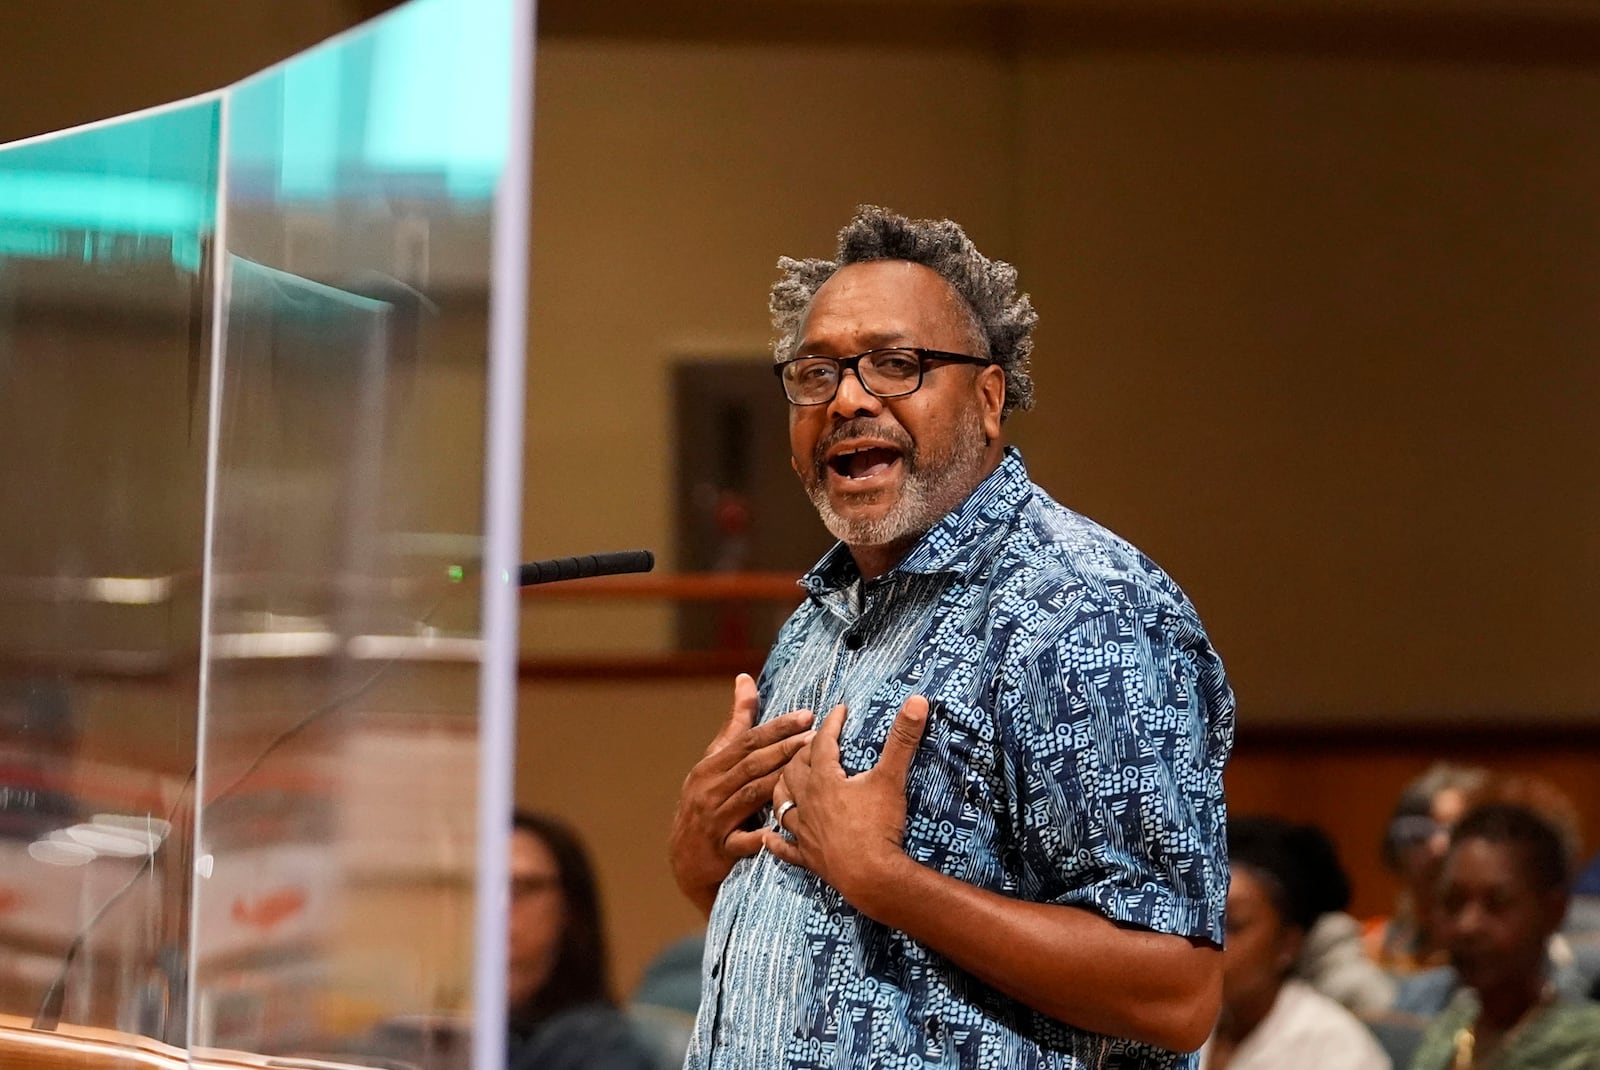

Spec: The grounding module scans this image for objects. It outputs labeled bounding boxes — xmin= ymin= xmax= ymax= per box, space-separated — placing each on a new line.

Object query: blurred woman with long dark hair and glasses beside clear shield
xmin=506 ymin=811 xmax=658 ymax=1070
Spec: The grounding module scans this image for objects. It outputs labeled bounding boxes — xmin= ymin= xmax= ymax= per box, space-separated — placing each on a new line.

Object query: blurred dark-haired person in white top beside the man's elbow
xmin=1200 ymin=817 xmax=1390 ymax=1070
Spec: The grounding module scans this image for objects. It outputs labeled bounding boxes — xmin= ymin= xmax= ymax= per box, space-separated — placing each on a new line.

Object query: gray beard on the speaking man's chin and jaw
xmin=806 ymin=411 xmax=989 ymax=545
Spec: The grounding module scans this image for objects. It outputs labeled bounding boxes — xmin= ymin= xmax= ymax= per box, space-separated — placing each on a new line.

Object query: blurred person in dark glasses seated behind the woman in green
xmin=1366 ymin=763 xmax=1490 ymax=974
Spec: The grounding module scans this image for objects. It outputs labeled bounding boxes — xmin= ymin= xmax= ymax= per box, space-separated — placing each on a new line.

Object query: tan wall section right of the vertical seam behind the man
xmin=1018 ymin=43 xmax=1600 ymax=721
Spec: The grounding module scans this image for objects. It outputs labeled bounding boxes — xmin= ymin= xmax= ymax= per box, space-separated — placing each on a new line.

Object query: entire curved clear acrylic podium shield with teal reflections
xmin=0 ymin=0 xmax=533 ymax=1068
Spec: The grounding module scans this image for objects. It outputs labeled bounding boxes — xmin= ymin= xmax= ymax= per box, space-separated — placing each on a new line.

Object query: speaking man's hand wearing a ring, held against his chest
xmin=762 ymin=694 xmax=928 ymax=916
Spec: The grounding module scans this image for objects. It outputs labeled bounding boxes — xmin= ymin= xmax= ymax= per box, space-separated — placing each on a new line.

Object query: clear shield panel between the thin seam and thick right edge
xmin=192 ymin=0 xmax=510 ymax=1067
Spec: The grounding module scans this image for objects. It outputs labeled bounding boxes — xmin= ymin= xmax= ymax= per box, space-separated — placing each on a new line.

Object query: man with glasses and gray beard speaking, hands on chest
xmin=672 ymin=208 xmax=1234 ymax=1070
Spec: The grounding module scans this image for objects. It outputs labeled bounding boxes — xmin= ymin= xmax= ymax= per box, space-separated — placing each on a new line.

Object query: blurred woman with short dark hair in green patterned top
xmin=1411 ymin=801 xmax=1600 ymax=1070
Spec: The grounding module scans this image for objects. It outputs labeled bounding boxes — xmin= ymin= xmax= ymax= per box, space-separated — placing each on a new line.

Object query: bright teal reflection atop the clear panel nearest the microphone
xmin=229 ymin=0 xmax=512 ymax=203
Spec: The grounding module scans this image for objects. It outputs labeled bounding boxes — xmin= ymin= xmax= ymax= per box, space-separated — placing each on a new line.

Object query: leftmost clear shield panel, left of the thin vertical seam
xmin=0 ymin=99 xmax=219 ymax=1043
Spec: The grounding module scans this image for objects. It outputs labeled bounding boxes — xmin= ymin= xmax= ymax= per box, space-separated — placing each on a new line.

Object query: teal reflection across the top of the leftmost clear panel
xmin=0 ymin=99 xmax=221 ymax=272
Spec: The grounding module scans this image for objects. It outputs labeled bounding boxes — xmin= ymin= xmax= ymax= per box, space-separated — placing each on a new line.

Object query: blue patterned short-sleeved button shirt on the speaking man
xmin=686 ymin=449 xmax=1234 ymax=1070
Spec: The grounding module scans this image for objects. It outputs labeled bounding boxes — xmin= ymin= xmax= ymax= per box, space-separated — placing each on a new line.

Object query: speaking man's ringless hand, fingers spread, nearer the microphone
xmin=670 ymin=672 xmax=813 ymax=916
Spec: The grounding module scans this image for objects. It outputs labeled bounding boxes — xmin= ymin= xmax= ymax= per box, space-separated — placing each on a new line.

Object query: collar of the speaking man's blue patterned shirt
xmin=800 ymin=446 xmax=1034 ymax=595
